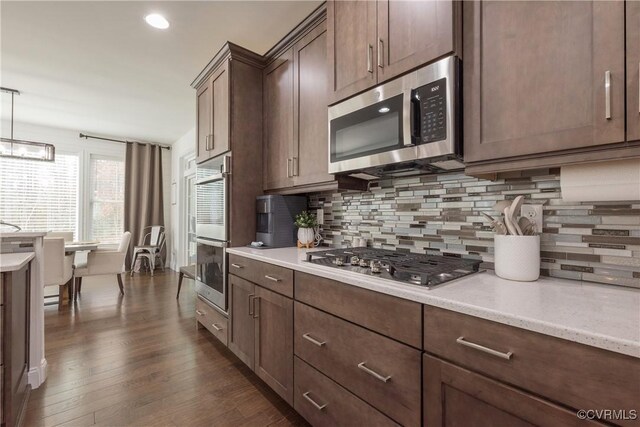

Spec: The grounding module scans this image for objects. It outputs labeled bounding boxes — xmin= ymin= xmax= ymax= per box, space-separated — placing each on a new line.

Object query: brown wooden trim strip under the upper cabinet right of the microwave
xmin=465 ymin=143 xmax=640 ymax=177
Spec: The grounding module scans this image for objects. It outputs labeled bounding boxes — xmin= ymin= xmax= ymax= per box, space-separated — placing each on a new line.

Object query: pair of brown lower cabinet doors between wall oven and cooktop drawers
xmin=229 ymin=274 xmax=293 ymax=404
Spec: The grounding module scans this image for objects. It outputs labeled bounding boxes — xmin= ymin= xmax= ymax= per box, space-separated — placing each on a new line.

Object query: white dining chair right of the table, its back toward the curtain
xmin=74 ymin=231 xmax=131 ymax=299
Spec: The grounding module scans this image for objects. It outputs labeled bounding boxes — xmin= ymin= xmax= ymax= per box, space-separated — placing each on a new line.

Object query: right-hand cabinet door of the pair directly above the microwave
xmin=376 ymin=0 xmax=457 ymax=83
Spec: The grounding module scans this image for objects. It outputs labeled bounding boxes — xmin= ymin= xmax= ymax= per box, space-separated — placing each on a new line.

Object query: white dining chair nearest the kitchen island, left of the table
xmin=44 ymin=237 xmax=73 ymax=305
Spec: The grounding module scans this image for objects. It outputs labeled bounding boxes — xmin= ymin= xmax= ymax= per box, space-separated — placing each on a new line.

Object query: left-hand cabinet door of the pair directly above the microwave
xmin=327 ymin=0 xmax=377 ymax=104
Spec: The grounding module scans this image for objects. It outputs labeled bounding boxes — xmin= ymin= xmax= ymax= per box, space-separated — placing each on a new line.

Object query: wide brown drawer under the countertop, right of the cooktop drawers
xmin=424 ymin=306 xmax=640 ymax=420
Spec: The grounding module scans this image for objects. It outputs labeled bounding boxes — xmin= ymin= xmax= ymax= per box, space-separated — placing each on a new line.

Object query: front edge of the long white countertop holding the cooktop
xmin=227 ymin=248 xmax=640 ymax=358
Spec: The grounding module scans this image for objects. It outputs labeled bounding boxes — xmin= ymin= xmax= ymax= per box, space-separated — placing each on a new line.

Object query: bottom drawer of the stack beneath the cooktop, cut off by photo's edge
xmin=294 ymin=357 xmax=398 ymax=426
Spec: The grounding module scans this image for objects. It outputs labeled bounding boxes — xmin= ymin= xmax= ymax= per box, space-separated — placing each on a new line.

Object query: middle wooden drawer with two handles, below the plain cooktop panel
xmin=294 ymin=302 xmax=421 ymax=425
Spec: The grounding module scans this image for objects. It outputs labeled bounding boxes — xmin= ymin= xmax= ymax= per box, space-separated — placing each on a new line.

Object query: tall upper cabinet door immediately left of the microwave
xmin=293 ymin=21 xmax=333 ymax=185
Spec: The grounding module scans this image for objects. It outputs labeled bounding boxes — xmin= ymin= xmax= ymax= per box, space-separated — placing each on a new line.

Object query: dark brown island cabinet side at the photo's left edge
xmin=0 ymin=264 xmax=31 ymax=427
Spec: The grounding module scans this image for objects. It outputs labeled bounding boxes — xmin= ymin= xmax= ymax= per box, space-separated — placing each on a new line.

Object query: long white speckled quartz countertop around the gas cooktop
xmin=228 ymin=247 xmax=640 ymax=358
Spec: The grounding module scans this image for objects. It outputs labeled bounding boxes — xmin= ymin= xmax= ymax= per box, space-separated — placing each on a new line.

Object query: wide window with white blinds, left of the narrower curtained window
xmin=0 ymin=153 xmax=80 ymax=239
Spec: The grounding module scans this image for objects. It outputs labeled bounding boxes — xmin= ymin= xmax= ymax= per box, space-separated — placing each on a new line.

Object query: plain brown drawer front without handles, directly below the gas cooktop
xmin=295 ymin=271 xmax=422 ymax=348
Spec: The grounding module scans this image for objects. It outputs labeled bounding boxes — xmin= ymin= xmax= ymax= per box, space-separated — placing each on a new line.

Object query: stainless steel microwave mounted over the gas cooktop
xmin=329 ymin=56 xmax=464 ymax=178
